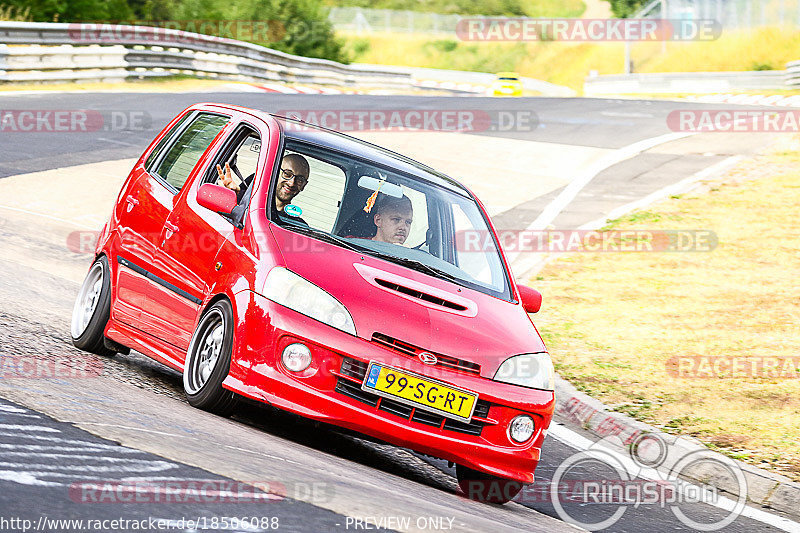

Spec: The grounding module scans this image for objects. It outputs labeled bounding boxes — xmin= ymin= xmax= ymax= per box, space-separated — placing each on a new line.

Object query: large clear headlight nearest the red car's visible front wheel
xmin=264 ymin=267 xmax=356 ymax=335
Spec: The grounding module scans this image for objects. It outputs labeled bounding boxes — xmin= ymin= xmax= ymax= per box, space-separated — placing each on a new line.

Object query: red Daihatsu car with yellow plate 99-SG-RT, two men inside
xmin=71 ymin=104 xmax=554 ymax=502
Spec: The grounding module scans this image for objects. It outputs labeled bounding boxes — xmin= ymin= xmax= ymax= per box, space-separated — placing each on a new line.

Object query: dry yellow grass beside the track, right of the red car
xmin=530 ymin=136 xmax=800 ymax=481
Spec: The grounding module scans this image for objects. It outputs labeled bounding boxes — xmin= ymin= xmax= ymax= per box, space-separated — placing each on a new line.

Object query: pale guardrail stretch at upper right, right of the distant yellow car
xmin=583 ymin=67 xmax=800 ymax=96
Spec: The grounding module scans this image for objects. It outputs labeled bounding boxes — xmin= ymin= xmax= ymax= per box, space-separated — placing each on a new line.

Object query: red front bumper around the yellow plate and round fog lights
xmin=224 ymin=291 xmax=554 ymax=483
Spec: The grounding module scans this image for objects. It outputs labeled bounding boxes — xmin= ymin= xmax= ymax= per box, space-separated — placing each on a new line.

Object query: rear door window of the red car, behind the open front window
xmin=155 ymin=113 xmax=228 ymax=190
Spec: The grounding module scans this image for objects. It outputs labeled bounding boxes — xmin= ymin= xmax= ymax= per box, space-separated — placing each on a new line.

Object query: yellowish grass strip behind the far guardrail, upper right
xmin=342 ymin=27 xmax=800 ymax=91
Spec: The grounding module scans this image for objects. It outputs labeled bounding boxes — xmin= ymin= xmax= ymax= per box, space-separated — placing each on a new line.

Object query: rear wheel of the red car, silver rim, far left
xmin=70 ymin=255 xmax=116 ymax=356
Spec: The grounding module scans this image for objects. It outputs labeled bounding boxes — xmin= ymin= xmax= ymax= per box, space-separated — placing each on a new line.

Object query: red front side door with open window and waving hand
xmin=148 ymin=119 xmax=261 ymax=350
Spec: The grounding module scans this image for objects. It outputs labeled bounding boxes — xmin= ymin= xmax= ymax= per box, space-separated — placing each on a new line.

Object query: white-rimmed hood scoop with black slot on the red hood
xmin=353 ymin=263 xmax=478 ymax=317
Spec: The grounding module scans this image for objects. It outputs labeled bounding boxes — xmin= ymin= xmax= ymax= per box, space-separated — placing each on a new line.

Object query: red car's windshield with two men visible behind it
xmin=273 ymin=140 xmax=510 ymax=300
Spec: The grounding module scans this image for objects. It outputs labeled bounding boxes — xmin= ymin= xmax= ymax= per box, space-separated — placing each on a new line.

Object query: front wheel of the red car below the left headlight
xmin=183 ymin=300 xmax=238 ymax=416
